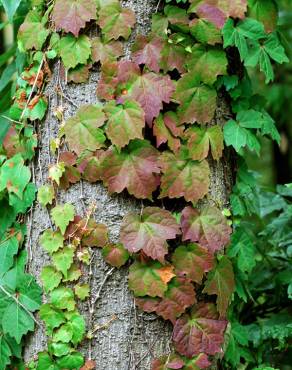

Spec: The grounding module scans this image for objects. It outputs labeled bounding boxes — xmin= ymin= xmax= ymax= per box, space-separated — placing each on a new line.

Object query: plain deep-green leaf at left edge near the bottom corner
xmin=1 ymin=301 xmax=34 ymax=343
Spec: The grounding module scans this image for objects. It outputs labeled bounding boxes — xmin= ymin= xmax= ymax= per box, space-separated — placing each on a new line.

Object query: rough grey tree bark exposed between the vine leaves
xmin=25 ymin=0 xmax=231 ymax=370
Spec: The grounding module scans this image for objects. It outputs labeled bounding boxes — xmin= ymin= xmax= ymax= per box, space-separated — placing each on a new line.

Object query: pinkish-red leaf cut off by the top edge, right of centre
xmin=189 ymin=0 xmax=247 ymax=29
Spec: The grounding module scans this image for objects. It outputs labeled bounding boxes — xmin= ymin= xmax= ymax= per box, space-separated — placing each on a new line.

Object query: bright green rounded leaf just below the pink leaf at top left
xmin=60 ymin=34 xmax=91 ymax=69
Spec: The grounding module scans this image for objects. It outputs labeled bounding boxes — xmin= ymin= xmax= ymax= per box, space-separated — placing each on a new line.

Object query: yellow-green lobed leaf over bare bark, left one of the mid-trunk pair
xmin=63 ymin=105 xmax=106 ymax=155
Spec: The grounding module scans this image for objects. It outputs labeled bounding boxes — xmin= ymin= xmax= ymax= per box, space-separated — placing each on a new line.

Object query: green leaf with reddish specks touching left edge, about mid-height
xmin=0 ymin=154 xmax=30 ymax=199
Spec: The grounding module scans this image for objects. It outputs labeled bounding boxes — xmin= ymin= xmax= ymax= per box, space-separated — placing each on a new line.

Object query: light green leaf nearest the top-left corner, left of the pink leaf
xmin=18 ymin=10 xmax=50 ymax=50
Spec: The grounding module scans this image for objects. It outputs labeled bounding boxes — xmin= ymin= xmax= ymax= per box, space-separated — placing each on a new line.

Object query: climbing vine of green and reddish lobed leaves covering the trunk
xmin=0 ymin=0 xmax=288 ymax=370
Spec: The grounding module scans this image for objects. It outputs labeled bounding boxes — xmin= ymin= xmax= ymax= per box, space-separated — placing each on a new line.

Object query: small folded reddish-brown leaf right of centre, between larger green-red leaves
xmin=153 ymin=112 xmax=184 ymax=153
